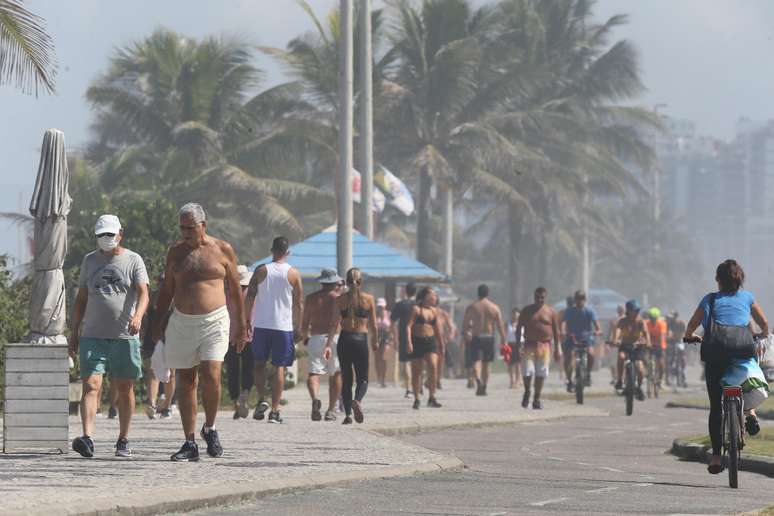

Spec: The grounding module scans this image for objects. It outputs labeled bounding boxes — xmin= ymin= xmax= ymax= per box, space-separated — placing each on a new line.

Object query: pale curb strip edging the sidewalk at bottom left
xmin=7 ymin=455 xmax=465 ymax=516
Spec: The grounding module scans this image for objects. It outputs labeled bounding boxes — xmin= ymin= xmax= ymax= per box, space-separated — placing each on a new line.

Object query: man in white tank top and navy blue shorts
xmin=245 ymin=237 xmax=304 ymax=423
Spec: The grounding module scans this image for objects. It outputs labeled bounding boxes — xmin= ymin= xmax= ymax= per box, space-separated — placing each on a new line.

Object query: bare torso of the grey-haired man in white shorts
xmin=172 ymin=236 xmax=236 ymax=315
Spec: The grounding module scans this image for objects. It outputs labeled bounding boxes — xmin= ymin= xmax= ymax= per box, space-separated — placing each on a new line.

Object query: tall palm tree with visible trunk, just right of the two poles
xmin=379 ymin=0 xmax=541 ymax=264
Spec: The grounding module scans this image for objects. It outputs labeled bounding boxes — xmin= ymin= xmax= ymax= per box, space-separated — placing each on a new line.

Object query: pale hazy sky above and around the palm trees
xmin=0 ymin=0 xmax=774 ymax=264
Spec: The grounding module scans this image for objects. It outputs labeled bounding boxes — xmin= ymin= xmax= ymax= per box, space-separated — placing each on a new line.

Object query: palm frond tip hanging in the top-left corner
xmin=0 ymin=0 xmax=56 ymax=96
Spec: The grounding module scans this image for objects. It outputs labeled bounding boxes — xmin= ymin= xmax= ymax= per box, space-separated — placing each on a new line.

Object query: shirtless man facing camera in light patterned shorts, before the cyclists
xmin=516 ymin=287 xmax=562 ymax=409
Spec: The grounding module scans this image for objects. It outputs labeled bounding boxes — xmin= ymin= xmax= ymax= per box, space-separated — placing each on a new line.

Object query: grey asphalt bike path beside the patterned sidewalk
xmin=186 ymin=388 xmax=774 ymax=516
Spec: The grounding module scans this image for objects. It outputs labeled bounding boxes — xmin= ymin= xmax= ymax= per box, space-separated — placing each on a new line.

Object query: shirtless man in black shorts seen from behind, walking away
xmin=462 ymin=285 xmax=507 ymax=396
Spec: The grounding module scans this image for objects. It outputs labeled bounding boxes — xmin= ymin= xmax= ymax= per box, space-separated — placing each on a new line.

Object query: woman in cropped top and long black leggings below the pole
xmin=325 ymin=267 xmax=379 ymax=425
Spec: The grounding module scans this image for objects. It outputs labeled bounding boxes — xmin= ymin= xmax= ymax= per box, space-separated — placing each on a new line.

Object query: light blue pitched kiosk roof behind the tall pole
xmin=250 ymin=231 xmax=448 ymax=283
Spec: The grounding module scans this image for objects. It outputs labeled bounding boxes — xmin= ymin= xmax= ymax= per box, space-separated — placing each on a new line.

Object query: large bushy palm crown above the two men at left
xmin=87 ymin=29 xmax=331 ymax=251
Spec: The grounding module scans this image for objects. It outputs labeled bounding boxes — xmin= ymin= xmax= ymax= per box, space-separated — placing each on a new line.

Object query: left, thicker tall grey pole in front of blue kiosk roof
xmin=336 ymin=0 xmax=354 ymax=275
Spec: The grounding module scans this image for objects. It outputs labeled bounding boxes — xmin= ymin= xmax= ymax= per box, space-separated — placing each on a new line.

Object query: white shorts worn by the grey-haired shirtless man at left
xmin=164 ymin=305 xmax=231 ymax=369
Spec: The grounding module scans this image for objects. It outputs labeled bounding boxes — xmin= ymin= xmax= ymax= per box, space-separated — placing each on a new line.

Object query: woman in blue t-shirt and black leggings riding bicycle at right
xmin=685 ymin=260 xmax=769 ymax=475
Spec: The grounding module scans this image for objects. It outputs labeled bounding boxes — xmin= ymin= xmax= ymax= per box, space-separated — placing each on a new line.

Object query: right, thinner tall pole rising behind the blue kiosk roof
xmin=358 ymin=0 xmax=374 ymax=239
